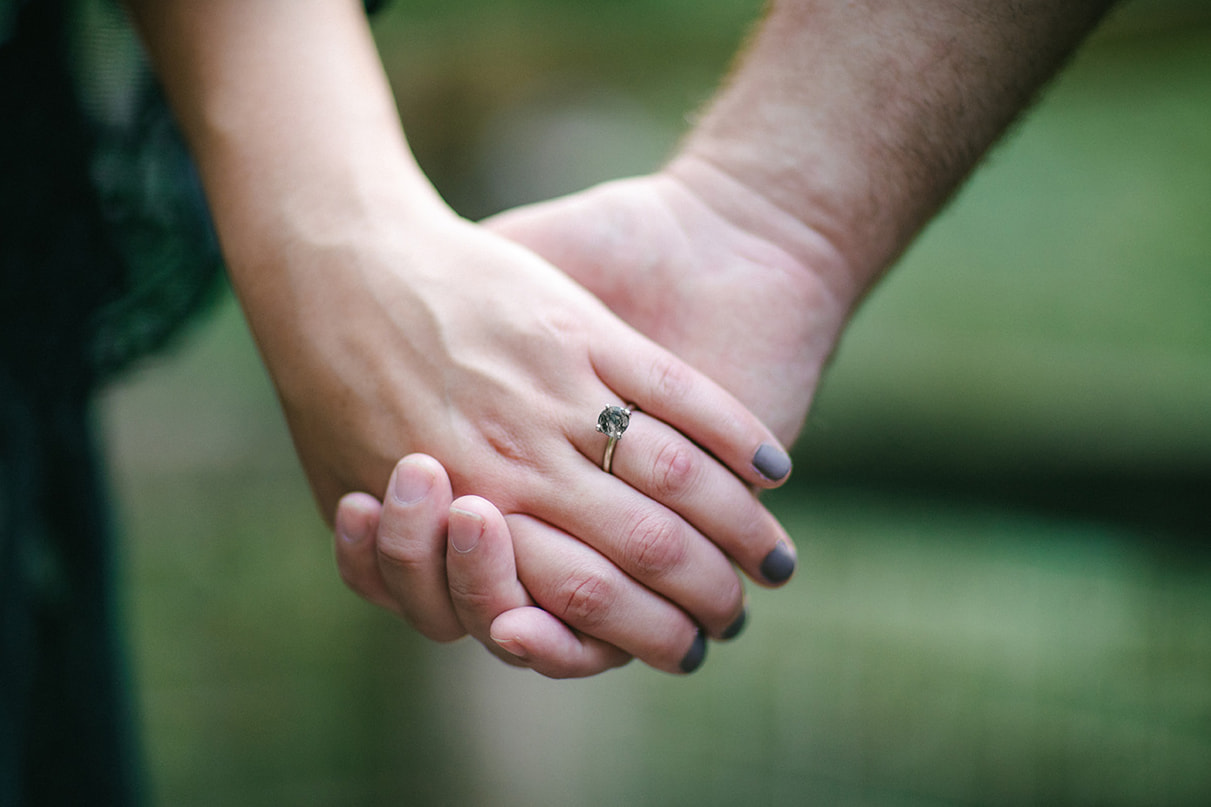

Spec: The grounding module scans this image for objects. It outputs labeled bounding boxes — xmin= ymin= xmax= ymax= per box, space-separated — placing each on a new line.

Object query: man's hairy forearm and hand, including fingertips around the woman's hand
xmin=337 ymin=0 xmax=1112 ymax=675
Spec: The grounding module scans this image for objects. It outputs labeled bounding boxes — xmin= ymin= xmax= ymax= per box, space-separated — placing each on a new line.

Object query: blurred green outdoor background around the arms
xmin=104 ymin=0 xmax=1211 ymax=806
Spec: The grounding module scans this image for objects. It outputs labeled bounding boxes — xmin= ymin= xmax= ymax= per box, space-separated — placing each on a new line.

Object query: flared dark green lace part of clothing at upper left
xmin=0 ymin=0 xmax=220 ymax=388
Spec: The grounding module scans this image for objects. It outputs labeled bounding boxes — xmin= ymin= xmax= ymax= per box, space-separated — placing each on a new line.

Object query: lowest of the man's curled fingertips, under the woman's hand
xmin=492 ymin=606 xmax=631 ymax=679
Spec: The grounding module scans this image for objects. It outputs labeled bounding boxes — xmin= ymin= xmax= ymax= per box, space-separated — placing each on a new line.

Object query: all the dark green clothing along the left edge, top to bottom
xmin=0 ymin=0 xmax=380 ymax=794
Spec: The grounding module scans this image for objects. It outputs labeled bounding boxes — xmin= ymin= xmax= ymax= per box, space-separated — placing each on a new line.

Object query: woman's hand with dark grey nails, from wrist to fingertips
xmin=295 ymin=217 xmax=793 ymax=671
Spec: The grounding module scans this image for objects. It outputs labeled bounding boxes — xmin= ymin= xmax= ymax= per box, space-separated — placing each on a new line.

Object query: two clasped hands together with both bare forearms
xmin=128 ymin=0 xmax=1109 ymax=676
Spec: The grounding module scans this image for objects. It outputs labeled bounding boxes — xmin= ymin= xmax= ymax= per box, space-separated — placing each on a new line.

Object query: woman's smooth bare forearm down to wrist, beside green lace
xmin=128 ymin=0 xmax=449 ymax=313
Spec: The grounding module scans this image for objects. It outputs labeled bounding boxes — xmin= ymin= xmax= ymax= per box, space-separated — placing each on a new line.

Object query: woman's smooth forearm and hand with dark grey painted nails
xmin=130 ymin=0 xmax=793 ymax=675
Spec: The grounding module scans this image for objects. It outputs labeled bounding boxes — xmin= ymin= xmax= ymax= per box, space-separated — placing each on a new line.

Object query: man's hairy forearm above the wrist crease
xmin=672 ymin=0 xmax=1112 ymax=299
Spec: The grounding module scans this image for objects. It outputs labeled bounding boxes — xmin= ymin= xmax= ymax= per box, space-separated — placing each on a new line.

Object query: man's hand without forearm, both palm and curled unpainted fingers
xmin=337 ymin=166 xmax=849 ymax=676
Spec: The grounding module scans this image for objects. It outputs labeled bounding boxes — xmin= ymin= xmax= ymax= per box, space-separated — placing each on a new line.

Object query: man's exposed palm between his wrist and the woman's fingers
xmin=486 ymin=164 xmax=855 ymax=445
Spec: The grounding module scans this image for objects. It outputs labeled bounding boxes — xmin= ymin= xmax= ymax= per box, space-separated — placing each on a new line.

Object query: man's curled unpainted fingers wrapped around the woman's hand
xmin=335 ymin=454 xmax=634 ymax=679
